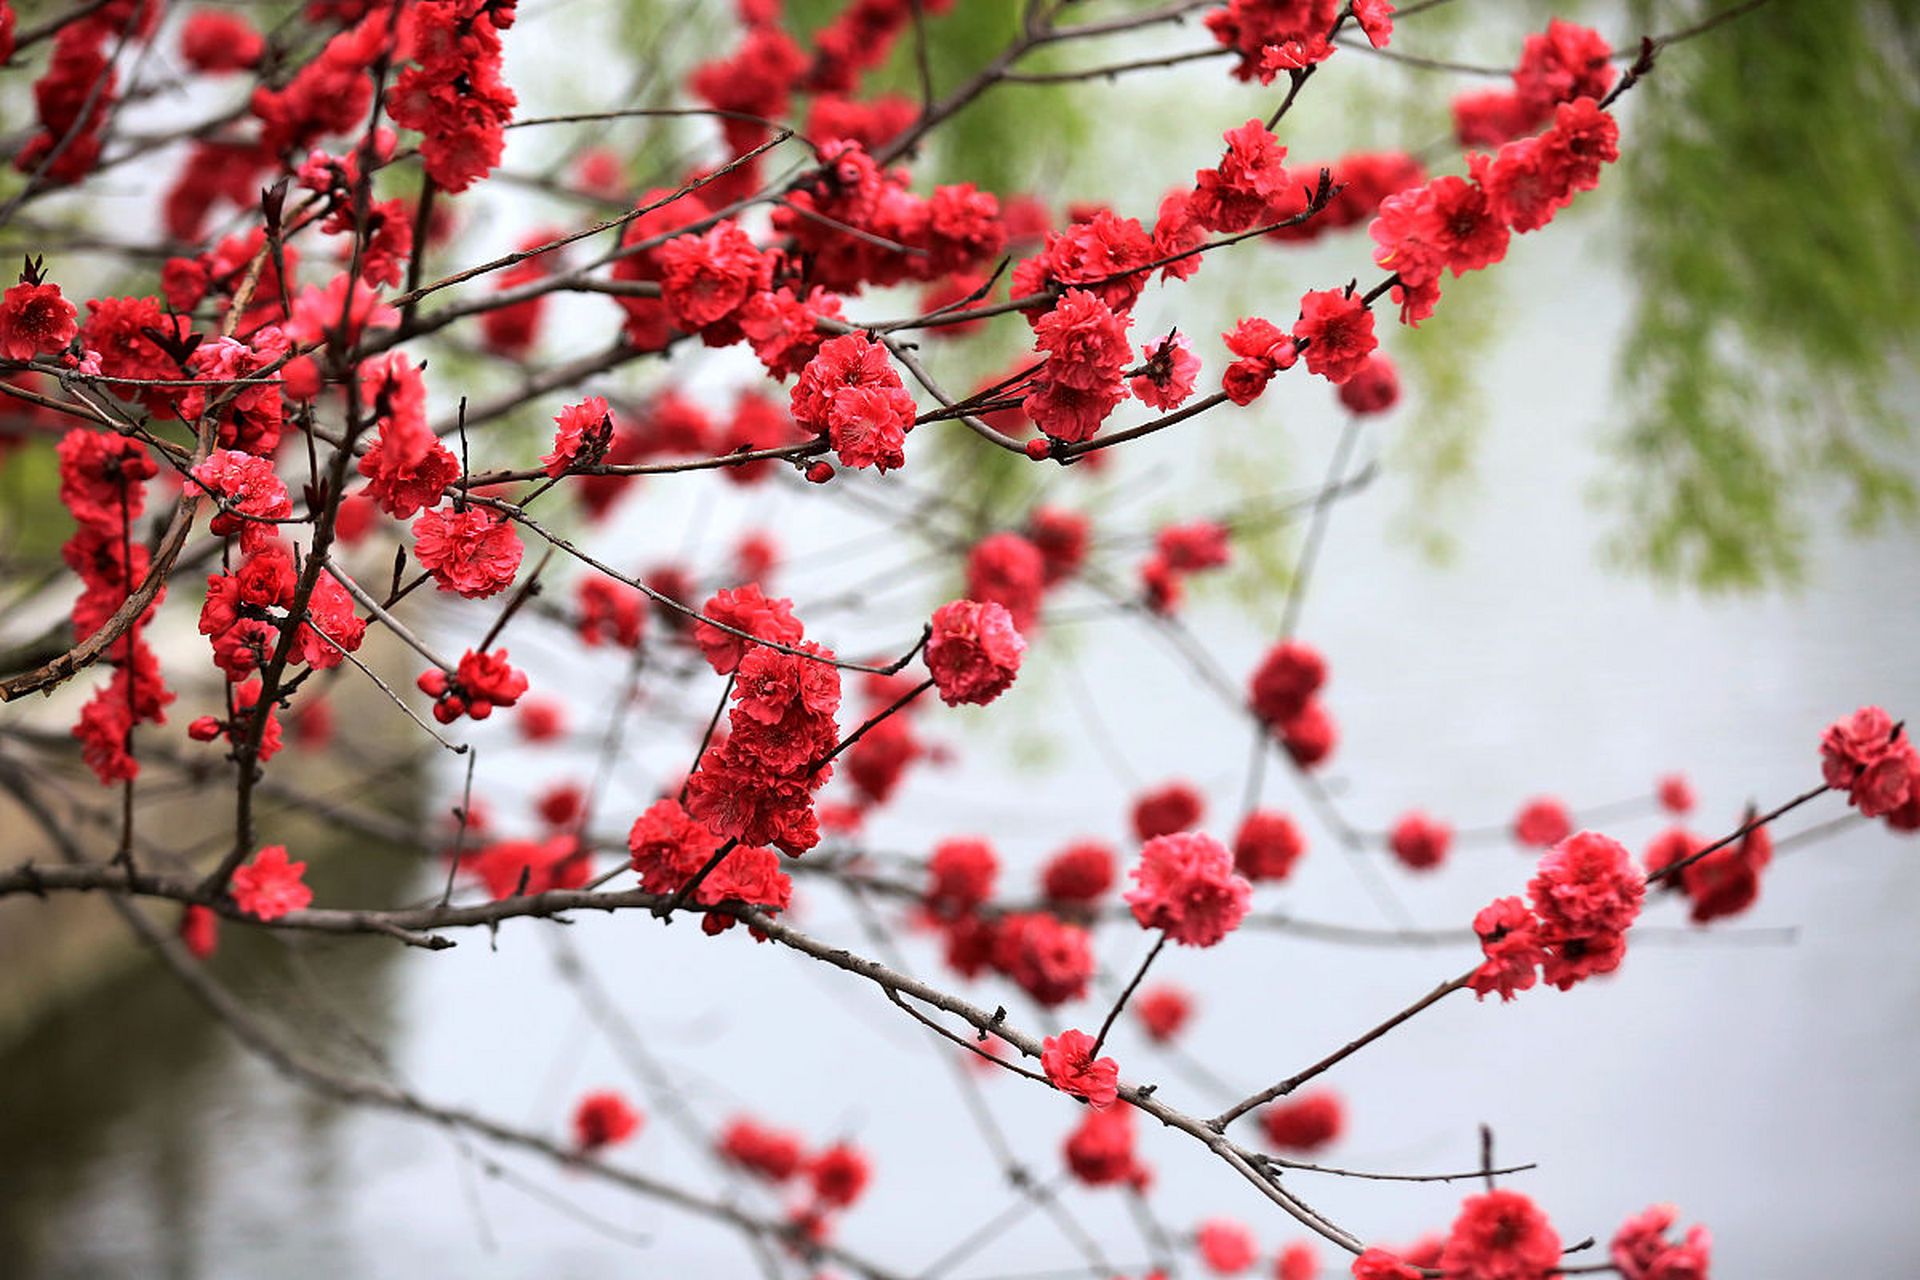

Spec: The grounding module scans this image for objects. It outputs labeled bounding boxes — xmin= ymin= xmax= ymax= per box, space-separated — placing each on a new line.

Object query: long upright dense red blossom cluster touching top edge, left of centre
xmin=378 ymin=0 xmax=518 ymax=192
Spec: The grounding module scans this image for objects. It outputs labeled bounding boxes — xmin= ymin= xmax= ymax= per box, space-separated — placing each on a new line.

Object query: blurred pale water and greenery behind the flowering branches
xmin=0 ymin=0 xmax=1920 ymax=1280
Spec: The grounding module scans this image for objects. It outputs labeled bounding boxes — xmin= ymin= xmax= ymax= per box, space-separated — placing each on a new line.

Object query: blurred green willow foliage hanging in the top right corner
xmin=1605 ymin=0 xmax=1920 ymax=589
